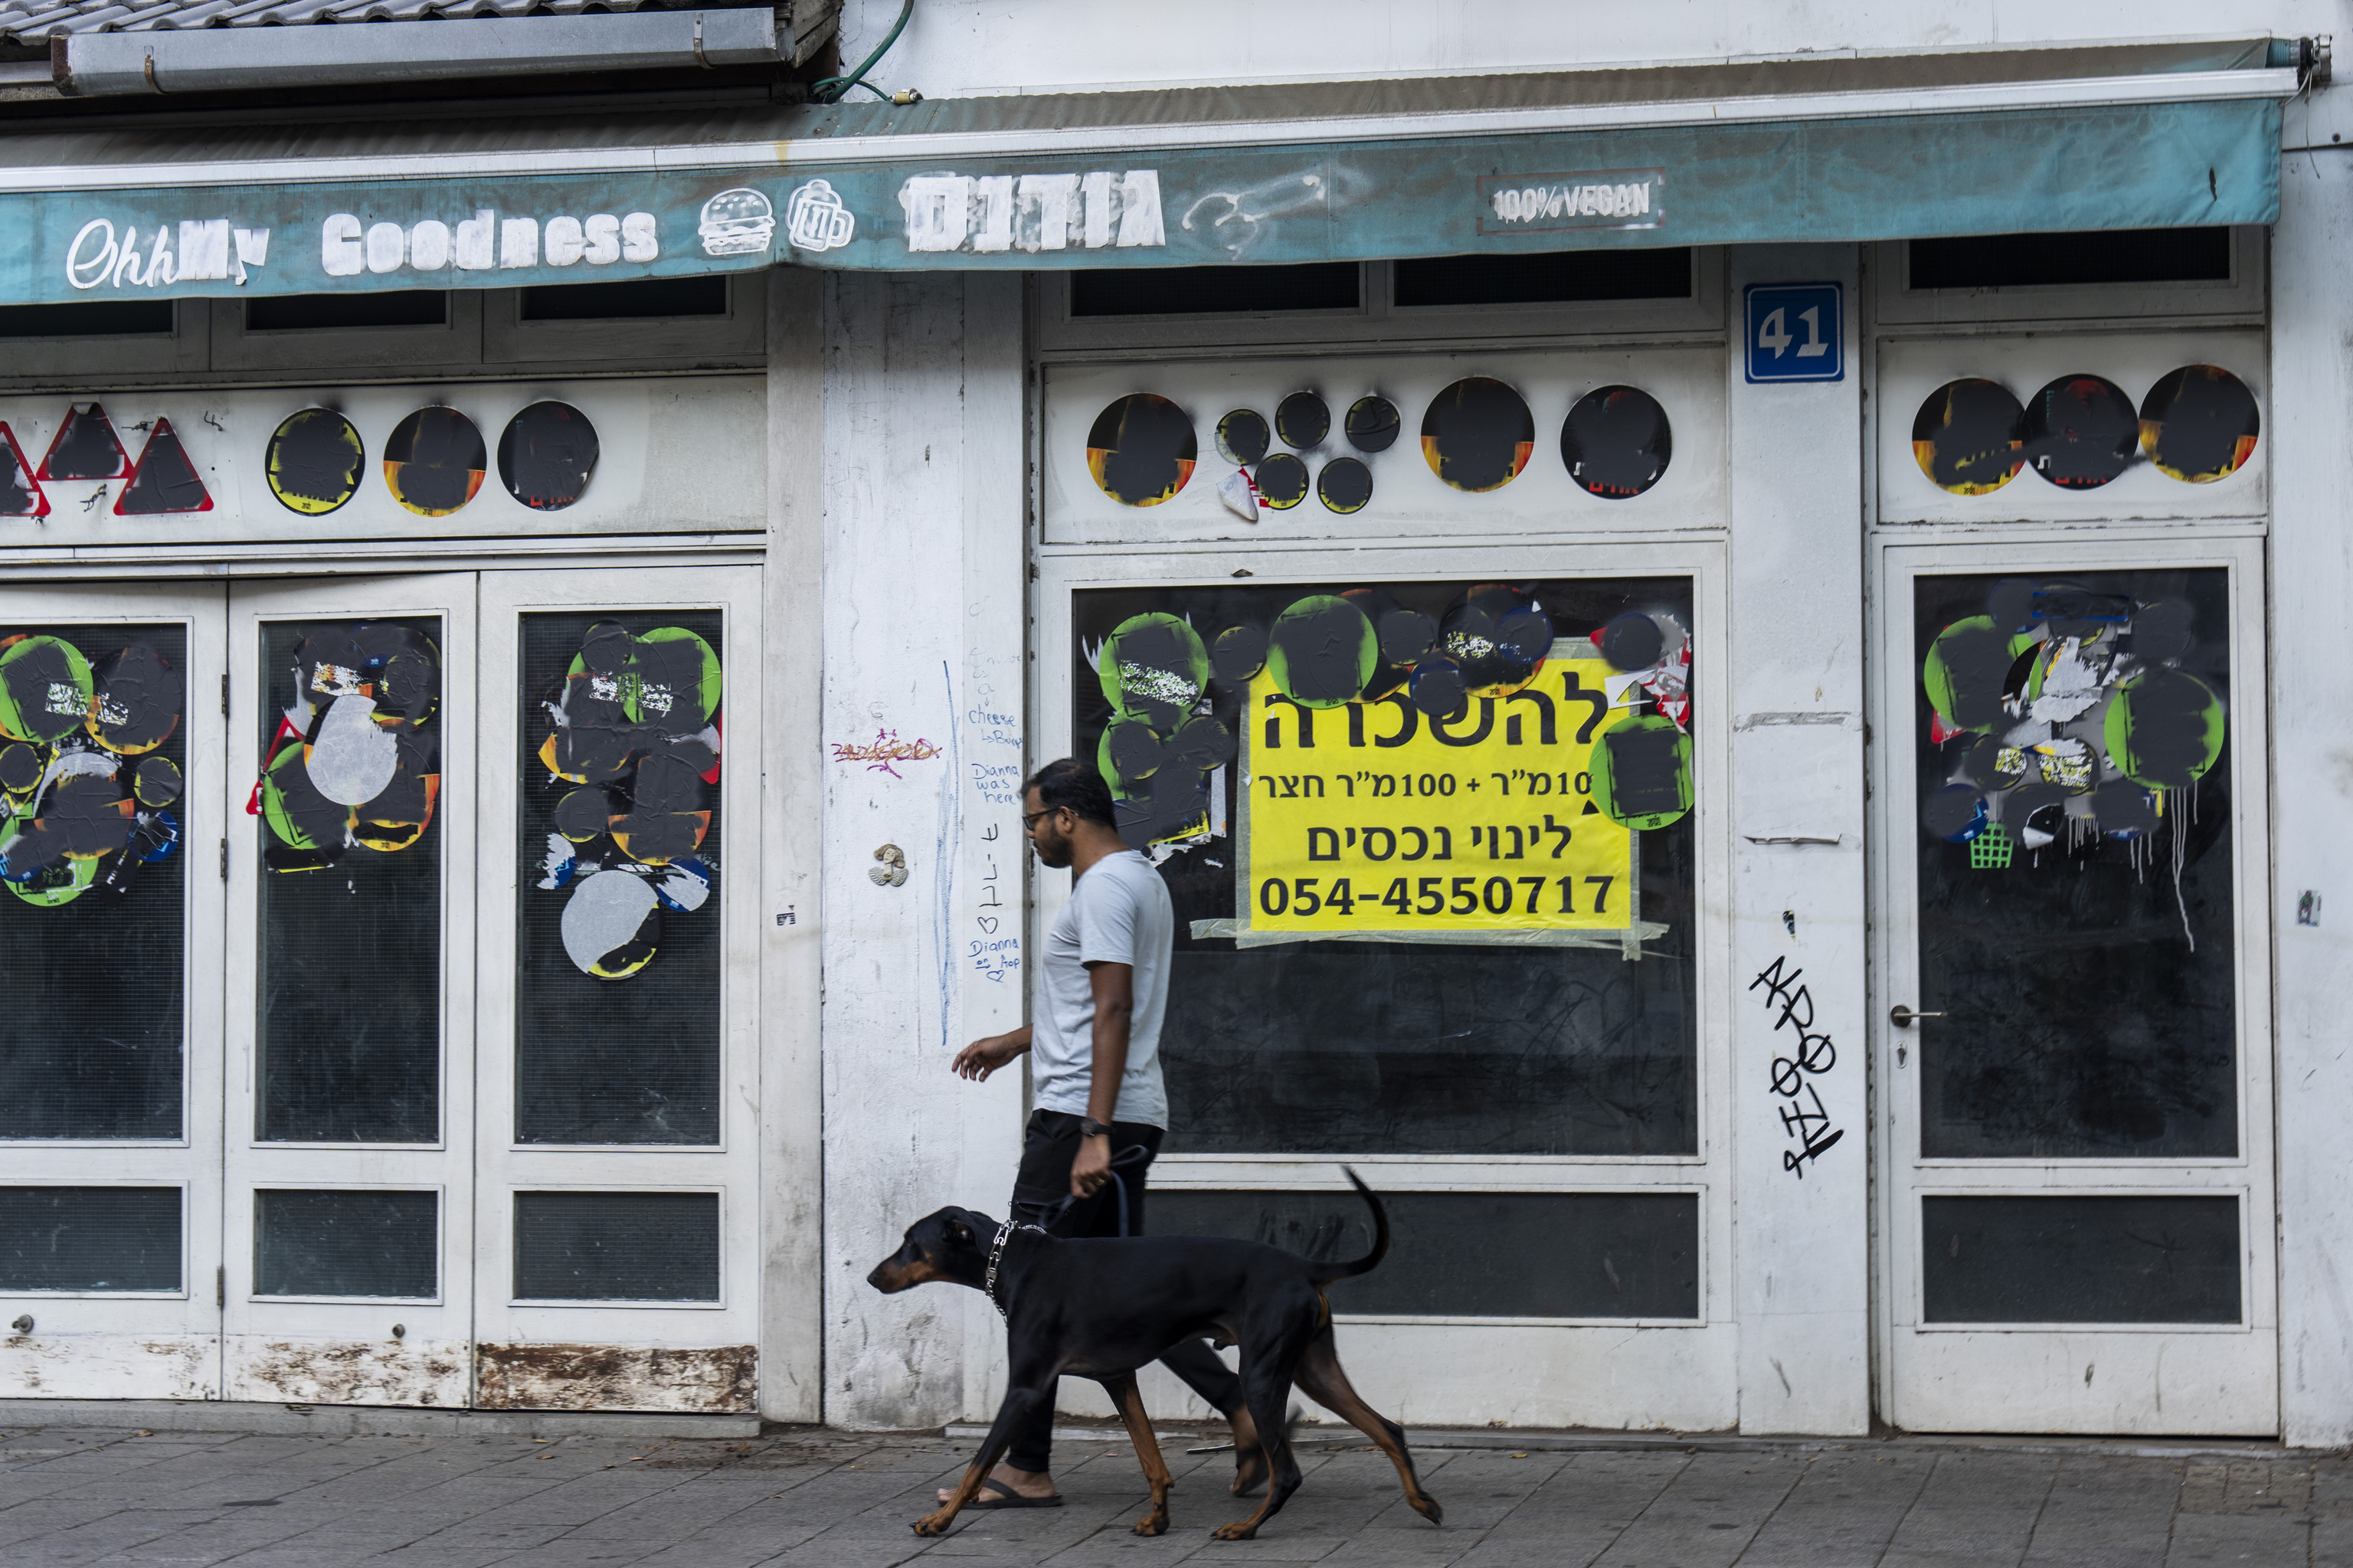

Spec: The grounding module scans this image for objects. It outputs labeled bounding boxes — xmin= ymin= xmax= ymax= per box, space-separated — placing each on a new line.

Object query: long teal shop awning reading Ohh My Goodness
xmin=0 ymin=81 xmax=2292 ymax=303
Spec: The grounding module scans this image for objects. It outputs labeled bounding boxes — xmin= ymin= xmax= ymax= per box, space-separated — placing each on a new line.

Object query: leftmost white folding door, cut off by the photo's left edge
xmin=0 ymin=586 xmax=226 ymax=1399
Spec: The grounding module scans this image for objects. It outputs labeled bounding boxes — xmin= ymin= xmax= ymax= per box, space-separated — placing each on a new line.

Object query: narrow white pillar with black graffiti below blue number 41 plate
xmin=1727 ymin=245 xmax=1870 ymax=1434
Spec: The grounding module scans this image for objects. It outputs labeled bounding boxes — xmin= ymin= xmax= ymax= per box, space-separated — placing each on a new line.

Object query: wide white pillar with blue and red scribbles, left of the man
xmin=813 ymin=273 xmax=1026 ymax=1427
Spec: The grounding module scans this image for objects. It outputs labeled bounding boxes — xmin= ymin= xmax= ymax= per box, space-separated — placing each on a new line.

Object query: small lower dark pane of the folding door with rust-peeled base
xmin=515 ymin=1191 xmax=720 ymax=1302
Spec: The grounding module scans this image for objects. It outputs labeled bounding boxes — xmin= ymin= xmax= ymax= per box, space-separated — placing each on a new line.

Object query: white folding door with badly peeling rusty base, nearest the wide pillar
xmin=476 ymin=568 xmax=767 ymax=1413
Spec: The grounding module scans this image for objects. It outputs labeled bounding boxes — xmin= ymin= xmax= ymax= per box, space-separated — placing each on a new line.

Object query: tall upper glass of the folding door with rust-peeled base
xmin=515 ymin=610 xmax=725 ymax=1144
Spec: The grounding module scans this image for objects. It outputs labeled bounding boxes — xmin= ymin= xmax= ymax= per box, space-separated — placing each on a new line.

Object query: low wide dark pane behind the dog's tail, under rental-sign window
xmin=1146 ymin=1191 xmax=1699 ymax=1318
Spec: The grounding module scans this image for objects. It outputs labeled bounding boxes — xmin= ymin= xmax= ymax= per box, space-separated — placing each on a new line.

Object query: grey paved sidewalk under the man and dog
xmin=0 ymin=1427 xmax=2353 ymax=1568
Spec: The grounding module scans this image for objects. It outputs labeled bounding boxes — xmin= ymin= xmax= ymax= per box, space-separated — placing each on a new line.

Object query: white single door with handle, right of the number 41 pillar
xmin=1873 ymin=535 xmax=2280 ymax=1436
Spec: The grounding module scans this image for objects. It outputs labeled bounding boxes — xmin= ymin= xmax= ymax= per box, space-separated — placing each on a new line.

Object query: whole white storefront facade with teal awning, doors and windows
xmin=0 ymin=0 xmax=2353 ymax=1445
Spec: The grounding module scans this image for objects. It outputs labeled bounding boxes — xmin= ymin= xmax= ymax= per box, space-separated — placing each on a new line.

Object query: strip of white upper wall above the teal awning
xmin=843 ymin=0 xmax=2353 ymax=99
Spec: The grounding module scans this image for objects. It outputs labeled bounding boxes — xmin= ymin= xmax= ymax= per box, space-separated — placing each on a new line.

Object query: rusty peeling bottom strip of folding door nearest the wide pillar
xmin=473 ymin=1344 xmax=760 ymax=1415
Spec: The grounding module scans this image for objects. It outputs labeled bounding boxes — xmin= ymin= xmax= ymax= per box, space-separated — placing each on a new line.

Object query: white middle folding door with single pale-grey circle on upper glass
xmin=221 ymin=572 xmax=478 ymax=1406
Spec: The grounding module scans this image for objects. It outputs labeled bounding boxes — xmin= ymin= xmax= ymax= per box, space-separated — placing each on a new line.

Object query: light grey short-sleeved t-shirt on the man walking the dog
xmin=1031 ymin=850 xmax=1176 ymax=1128
